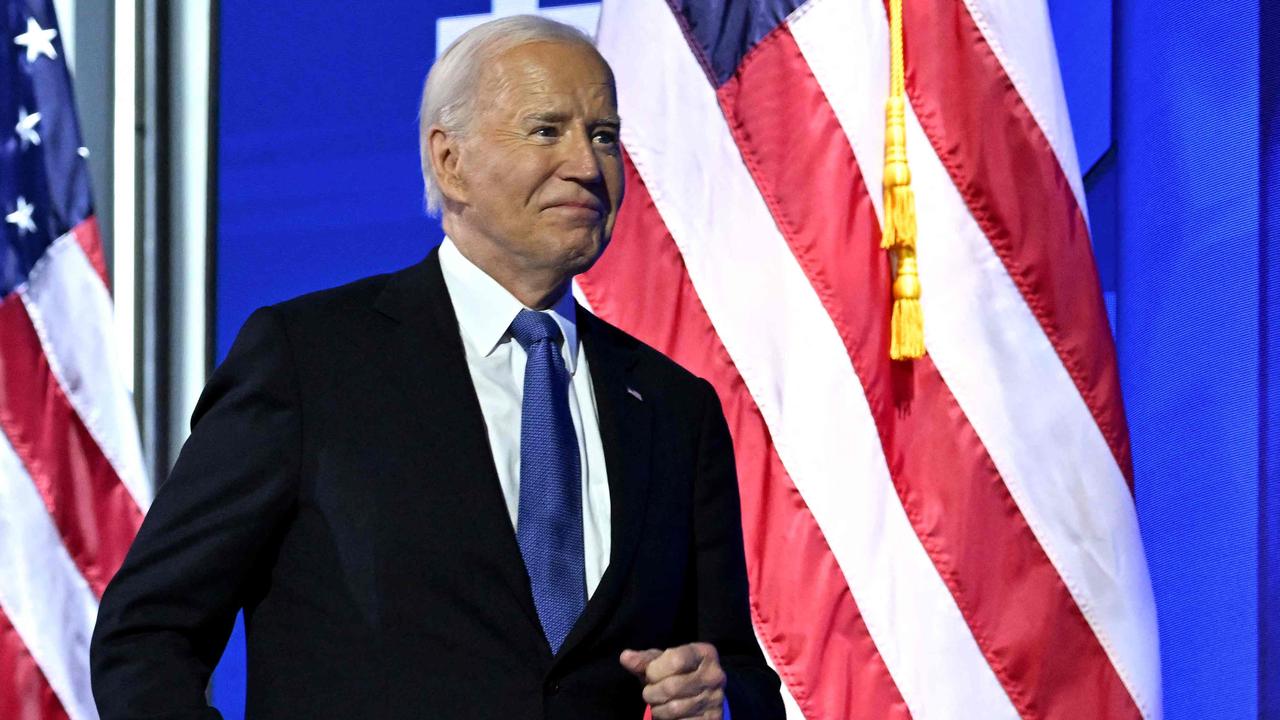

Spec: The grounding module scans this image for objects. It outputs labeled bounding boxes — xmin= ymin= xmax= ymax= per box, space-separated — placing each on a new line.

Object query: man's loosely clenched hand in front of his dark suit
xmin=618 ymin=643 xmax=724 ymax=720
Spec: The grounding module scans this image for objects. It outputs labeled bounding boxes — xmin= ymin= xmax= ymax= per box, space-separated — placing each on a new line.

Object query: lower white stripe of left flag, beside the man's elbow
xmin=0 ymin=433 xmax=97 ymax=720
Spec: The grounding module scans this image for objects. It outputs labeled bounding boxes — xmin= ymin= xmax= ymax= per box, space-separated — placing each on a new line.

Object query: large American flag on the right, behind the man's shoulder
xmin=579 ymin=0 xmax=1161 ymax=720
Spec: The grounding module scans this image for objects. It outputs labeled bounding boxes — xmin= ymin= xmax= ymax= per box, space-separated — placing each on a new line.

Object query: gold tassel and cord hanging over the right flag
xmin=881 ymin=0 xmax=924 ymax=360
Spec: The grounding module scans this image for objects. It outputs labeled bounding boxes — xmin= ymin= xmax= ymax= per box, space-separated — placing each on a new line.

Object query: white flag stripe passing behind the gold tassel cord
xmin=791 ymin=0 xmax=1160 ymax=716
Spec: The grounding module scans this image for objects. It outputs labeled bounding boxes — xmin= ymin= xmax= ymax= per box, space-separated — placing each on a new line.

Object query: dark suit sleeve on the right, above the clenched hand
xmin=694 ymin=382 xmax=786 ymax=720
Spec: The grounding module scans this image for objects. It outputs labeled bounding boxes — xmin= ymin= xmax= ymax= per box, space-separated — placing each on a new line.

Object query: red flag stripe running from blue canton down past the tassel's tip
xmin=718 ymin=26 xmax=1138 ymax=717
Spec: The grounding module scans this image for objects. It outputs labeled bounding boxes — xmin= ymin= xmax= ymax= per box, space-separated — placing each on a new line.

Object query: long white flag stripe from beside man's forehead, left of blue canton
xmin=599 ymin=0 xmax=1016 ymax=717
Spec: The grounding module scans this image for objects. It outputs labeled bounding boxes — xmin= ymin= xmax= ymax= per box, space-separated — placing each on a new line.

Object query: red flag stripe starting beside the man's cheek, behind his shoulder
xmin=579 ymin=152 xmax=910 ymax=719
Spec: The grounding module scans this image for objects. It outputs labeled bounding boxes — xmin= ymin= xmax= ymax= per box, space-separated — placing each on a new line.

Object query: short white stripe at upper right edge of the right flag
xmin=957 ymin=0 xmax=1088 ymax=212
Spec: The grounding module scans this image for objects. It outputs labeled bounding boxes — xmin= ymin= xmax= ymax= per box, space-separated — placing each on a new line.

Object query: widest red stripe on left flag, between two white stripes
xmin=0 ymin=293 xmax=142 ymax=597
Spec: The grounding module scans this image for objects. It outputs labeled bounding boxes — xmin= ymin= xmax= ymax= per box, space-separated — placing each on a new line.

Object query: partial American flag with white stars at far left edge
xmin=0 ymin=0 xmax=151 ymax=720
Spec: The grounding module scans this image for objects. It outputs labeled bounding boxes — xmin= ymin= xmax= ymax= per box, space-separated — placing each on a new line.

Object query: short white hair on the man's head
xmin=419 ymin=15 xmax=603 ymax=215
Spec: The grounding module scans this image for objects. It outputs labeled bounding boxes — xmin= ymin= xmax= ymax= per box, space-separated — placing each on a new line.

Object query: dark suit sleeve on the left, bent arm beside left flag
xmin=90 ymin=309 xmax=301 ymax=720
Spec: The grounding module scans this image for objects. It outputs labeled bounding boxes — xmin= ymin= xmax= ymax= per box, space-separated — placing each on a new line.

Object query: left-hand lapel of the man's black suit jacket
xmin=376 ymin=249 xmax=541 ymax=633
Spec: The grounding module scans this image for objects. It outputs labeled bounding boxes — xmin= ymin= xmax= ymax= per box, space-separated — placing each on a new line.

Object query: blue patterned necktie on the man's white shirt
xmin=511 ymin=304 xmax=586 ymax=653
